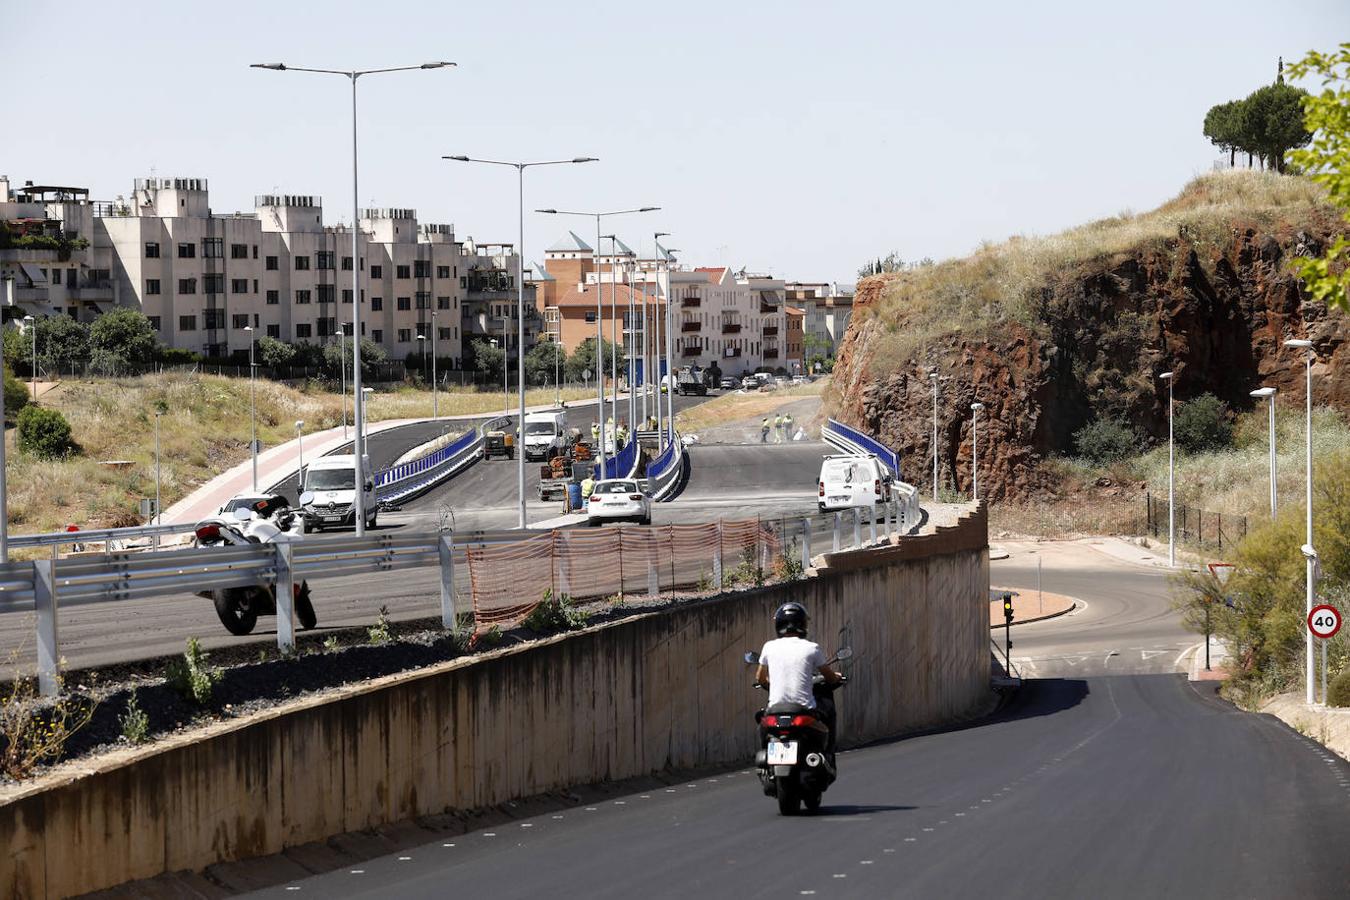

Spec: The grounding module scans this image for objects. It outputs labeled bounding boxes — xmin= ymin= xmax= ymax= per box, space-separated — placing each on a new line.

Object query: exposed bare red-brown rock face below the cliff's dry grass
xmin=833 ymin=216 xmax=1350 ymax=499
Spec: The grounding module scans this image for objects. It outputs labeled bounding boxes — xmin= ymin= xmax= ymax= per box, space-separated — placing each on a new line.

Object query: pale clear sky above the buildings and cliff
xmin=0 ymin=0 xmax=1350 ymax=282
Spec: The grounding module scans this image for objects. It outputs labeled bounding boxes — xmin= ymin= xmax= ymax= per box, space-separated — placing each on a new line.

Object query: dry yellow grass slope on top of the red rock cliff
xmin=863 ymin=170 xmax=1327 ymax=374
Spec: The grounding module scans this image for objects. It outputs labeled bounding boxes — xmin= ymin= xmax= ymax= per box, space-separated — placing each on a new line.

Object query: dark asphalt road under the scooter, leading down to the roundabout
xmin=251 ymin=545 xmax=1350 ymax=900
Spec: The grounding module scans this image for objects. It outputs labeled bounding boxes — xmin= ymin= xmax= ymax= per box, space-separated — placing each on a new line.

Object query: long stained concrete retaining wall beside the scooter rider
xmin=0 ymin=507 xmax=990 ymax=897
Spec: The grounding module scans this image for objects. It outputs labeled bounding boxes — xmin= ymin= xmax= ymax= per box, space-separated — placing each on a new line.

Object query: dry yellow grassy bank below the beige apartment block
xmin=7 ymin=374 xmax=589 ymax=533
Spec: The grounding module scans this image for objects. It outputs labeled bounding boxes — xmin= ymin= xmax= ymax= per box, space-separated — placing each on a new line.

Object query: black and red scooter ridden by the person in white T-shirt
xmin=745 ymin=648 xmax=853 ymax=815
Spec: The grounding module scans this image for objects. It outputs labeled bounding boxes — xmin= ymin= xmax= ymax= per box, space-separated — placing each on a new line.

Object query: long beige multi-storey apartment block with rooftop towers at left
xmin=0 ymin=178 xmax=541 ymax=367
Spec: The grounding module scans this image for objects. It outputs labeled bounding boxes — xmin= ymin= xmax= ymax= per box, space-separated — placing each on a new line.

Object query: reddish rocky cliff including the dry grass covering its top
xmin=830 ymin=175 xmax=1350 ymax=498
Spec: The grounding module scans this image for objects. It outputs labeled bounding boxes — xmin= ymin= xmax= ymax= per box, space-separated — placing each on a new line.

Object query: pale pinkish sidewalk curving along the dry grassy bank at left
xmin=162 ymin=394 xmax=626 ymax=524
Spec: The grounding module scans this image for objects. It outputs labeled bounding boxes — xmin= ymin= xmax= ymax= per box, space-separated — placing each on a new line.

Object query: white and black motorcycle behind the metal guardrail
xmin=194 ymin=497 xmax=319 ymax=636
